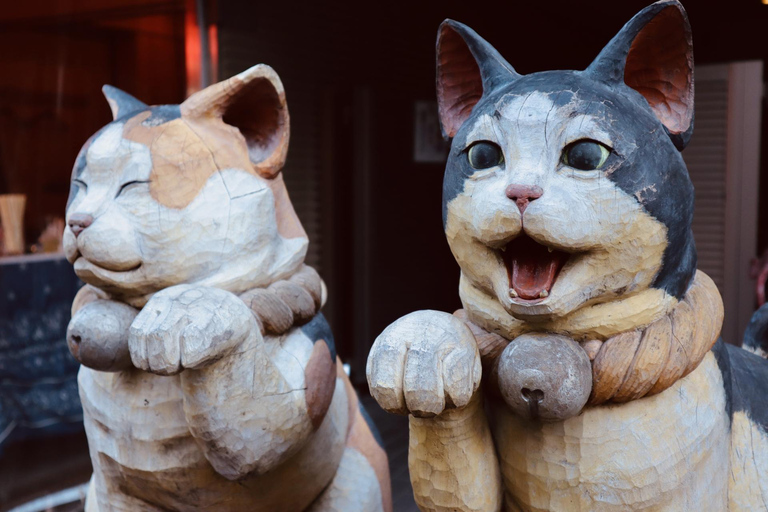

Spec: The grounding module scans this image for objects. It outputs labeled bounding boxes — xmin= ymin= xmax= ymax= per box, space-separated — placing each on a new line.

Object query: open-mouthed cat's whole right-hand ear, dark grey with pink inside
xmin=586 ymin=0 xmax=693 ymax=151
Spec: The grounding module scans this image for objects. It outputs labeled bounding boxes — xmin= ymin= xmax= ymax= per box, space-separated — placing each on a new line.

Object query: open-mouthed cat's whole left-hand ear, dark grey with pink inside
xmin=437 ymin=20 xmax=520 ymax=138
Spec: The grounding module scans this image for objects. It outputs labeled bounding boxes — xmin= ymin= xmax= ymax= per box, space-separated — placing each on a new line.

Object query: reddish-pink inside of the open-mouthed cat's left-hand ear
xmin=437 ymin=25 xmax=483 ymax=137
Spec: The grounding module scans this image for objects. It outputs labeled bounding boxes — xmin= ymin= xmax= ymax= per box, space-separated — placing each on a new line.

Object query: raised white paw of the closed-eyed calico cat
xmin=128 ymin=284 xmax=258 ymax=375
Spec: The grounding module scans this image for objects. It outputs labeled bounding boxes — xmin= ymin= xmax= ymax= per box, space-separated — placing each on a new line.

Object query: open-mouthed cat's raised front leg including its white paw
xmin=367 ymin=311 xmax=502 ymax=512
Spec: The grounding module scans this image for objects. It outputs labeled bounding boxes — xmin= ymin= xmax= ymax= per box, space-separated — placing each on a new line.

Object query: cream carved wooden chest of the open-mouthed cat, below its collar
xmin=492 ymin=354 xmax=729 ymax=511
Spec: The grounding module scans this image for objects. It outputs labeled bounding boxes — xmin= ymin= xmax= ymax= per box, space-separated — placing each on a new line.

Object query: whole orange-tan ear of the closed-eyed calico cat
xmin=181 ymin=64 xmax=290 ymax=178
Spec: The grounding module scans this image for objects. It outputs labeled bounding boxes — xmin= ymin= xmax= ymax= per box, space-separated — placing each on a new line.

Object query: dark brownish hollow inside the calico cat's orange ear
xmin=223 ymin=78 xmax=288 ymax=174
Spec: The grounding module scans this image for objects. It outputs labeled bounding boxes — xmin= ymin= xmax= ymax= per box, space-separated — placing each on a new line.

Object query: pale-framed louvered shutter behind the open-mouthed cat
xmin=683 ymin=61 xmax=763 ymax=344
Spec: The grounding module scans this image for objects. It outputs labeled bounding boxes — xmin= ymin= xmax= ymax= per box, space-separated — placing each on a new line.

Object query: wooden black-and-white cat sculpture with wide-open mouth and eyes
xmin=368 ymin=0 xmax=768 ymax=512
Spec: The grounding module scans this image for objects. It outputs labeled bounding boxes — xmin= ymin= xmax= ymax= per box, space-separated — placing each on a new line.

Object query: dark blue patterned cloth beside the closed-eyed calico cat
xmin=0 ymin=255 xmax=83 ymax=450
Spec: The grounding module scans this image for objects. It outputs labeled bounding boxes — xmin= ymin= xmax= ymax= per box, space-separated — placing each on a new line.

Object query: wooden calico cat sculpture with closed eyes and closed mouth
xmin=64 ymin=65 xmax=391 ymax=512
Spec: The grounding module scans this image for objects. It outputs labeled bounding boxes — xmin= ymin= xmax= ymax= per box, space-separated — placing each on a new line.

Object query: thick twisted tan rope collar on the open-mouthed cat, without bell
xmin=462 ymin=270 xmax=723 ymax=405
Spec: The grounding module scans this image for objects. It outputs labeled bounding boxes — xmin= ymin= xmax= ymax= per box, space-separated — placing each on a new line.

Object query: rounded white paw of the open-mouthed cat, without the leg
xmin=366 ymin=311 xmax=482 ymax=417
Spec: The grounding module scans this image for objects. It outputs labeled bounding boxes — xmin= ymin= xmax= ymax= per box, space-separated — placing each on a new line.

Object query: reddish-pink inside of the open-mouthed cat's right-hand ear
xmin=624 ymin=6 xmax=693 ymax=134
